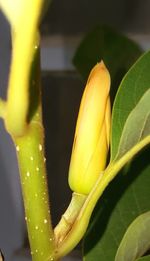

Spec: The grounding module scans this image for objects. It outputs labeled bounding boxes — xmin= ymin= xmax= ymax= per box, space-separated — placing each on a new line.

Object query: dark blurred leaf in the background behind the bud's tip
xmin=73 ymin=26 xmax=142 ymax=100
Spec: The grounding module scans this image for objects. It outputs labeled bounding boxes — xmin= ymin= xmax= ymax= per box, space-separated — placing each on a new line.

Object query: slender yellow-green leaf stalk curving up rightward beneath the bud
xmin=56 ymin=136 xmax=150 ymax=258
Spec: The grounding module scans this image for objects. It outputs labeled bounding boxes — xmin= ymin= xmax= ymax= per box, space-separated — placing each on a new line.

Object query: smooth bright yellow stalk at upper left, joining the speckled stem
xmin=0 ymin=0 xmax=44 ymax=137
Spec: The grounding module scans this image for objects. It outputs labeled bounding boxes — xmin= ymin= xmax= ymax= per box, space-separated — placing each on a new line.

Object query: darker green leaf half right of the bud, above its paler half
xmin=111 ymin=52 xmax=150 ymax=160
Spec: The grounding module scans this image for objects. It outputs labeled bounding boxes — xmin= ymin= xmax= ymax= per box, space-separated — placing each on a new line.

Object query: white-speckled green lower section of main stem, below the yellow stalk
xmin=14 ymin=121 xmax=54 ymax=261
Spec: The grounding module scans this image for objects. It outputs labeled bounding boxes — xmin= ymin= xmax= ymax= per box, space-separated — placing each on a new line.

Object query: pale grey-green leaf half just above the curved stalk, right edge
xmin=117 ymin=89 xmax=150 ymax=159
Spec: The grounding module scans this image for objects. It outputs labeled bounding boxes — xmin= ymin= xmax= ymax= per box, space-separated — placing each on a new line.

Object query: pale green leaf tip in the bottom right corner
xmin=115 ymin=211 xmax=150 ymax=261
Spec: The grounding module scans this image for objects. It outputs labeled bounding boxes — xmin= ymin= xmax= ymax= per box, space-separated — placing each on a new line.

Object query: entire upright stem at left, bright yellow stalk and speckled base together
xmin=0 ymin=0 xmax=56 ymax=261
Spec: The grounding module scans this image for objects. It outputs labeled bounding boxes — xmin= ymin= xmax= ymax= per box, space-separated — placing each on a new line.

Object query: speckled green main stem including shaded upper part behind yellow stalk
xmin=6 ymin=42 xmax=57 ymax=261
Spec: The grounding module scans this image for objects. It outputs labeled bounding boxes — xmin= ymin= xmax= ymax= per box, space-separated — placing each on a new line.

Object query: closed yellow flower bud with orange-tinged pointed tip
xmin=69 ymin=61 xmax=111 ymax=194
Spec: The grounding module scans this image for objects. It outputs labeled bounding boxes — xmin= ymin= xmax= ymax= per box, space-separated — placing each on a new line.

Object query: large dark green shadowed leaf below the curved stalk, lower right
xmin=83 ymin=148 xmax=150 ymax=261
